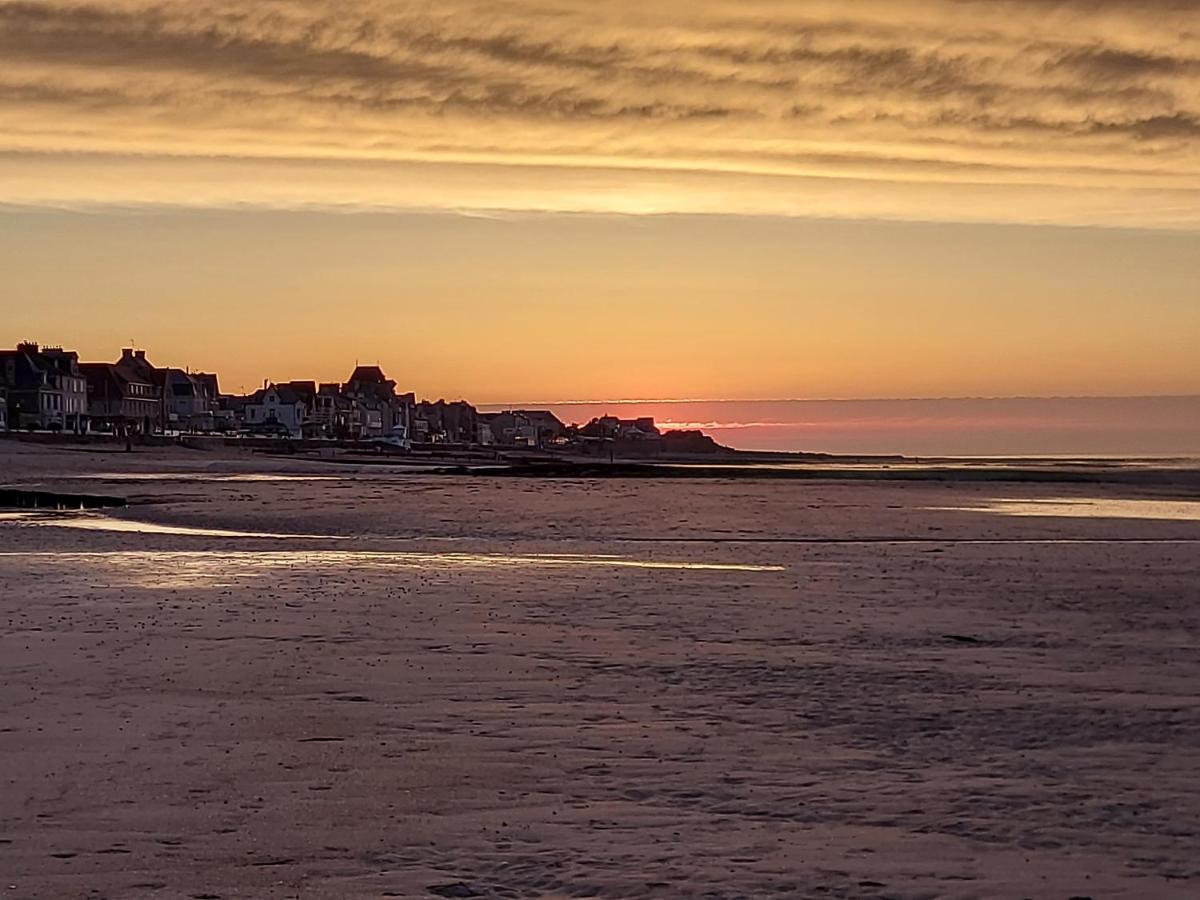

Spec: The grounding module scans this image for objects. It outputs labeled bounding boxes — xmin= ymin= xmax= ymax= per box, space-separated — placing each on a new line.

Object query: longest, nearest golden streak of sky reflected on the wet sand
xmin=0 ymin=550 xmax=785 ymax=588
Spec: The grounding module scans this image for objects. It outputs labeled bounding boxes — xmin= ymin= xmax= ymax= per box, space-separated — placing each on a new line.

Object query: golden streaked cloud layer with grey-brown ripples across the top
xmin=0 ymin=0 xmax=1200 ymax=228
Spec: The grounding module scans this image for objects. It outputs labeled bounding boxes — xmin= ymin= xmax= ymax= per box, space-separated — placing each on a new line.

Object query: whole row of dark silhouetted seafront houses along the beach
xmin=0 ymin=342 xmax=662 ymax=448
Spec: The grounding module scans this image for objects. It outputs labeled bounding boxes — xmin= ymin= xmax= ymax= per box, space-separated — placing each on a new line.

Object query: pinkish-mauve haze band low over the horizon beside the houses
xmin=485 ymin=395 xmax=1200 ymax=457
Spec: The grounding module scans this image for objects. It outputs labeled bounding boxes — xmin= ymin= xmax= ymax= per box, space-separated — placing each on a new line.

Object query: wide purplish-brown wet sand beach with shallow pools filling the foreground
xmin=0 ymin=444 xmax=1200 ymax=900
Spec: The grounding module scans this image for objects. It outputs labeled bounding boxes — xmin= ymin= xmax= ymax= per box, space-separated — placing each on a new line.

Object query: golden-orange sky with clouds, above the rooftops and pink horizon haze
xmin=0 ymin=0 xmax=1200 ymax=448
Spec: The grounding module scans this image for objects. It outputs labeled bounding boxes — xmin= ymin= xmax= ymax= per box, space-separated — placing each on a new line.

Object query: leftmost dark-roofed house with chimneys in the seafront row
xmin=0 ymin=342 xmax=89 ymax=433
